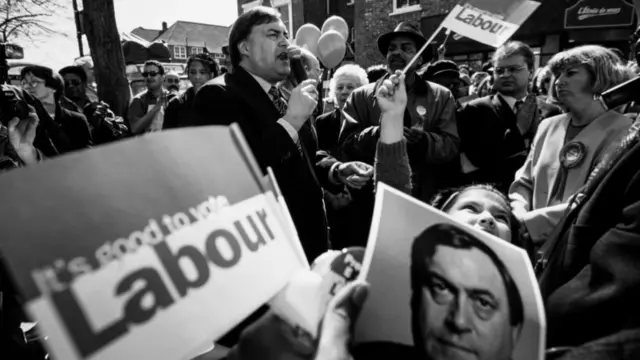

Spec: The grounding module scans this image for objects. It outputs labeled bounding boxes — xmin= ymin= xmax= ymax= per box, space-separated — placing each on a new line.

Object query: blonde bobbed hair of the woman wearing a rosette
xmin=548 ymin=45 xmax=633 ymax=95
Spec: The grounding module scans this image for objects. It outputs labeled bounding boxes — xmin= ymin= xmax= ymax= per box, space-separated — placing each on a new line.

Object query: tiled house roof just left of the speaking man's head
xmin=153 ymin=21 xmax=229 ymax=53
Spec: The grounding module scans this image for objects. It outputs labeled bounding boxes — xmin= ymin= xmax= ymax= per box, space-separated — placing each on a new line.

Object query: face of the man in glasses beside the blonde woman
xmin=493 ymin=55 xmax=531 ymax=96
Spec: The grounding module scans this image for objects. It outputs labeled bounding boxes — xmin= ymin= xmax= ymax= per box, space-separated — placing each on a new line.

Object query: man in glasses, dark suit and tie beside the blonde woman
xmin=457 ymin=41 xmax=561 ymax=193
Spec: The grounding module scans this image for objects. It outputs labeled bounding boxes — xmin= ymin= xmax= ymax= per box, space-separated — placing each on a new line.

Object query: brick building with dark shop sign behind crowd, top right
xmin=355 ymin=0 xmax=636 ymax=68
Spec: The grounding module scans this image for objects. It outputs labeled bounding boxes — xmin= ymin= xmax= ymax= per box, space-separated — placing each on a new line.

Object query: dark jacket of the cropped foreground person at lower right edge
xmin=538 ymin=127 xmax=640 ymax=347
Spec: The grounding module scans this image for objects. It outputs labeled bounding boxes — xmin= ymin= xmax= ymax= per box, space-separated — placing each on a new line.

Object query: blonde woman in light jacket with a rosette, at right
xmin=509 ymin=45 xmax=631 ymax=244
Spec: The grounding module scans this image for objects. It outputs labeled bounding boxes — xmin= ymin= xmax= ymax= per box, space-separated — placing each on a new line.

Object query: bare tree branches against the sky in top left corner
xmin=0 ymin=0 xmax=65 ymax=41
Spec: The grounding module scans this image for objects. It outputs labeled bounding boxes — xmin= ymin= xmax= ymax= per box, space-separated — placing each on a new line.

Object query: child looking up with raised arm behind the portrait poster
xmin=375 ymin=71 xmax=534 ymax=260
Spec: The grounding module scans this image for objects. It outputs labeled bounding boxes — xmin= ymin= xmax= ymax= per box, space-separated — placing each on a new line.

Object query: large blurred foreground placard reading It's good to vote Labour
xmin=0 ymin=127 xmax=303 ymax=360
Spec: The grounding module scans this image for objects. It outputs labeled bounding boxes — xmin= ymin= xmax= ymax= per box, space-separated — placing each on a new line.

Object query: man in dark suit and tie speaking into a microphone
xmin=195 ymin=6 xmax=373 ymax=261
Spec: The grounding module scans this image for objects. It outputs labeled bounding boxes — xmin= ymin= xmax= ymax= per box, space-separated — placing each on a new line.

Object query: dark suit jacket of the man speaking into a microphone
xmin=195 ymin=67 xmax=336 ymax=262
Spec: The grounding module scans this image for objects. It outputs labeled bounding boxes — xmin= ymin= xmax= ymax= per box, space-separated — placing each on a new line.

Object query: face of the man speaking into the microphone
xmin=239 ymin=21 xmax=291 ymax=83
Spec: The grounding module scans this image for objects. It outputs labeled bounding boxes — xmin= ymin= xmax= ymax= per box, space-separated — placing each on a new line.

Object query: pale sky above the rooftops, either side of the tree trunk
xmin=15 ymin=0 xmax=238 ymax=70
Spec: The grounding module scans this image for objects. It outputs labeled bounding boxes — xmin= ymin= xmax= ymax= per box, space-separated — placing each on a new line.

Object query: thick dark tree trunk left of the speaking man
xmin=82 ymin=0 xmax=131 ymax=118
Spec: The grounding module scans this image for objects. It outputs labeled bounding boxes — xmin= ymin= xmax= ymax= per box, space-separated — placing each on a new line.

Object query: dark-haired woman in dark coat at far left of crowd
xmin=20 ymin=65 xmax=92 ymax=154
